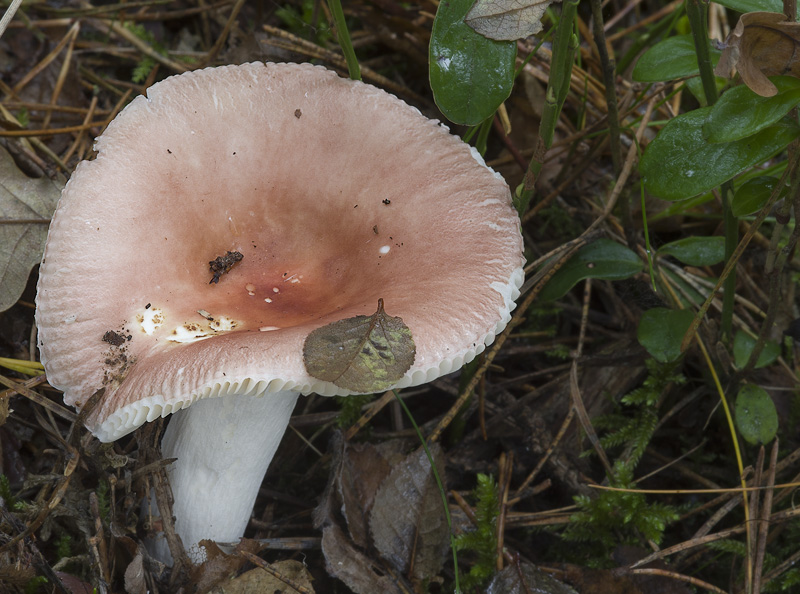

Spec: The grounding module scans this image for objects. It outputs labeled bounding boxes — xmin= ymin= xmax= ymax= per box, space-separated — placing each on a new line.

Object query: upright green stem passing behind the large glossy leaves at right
xmin=686 ymin=0 xmax=739 ymax=340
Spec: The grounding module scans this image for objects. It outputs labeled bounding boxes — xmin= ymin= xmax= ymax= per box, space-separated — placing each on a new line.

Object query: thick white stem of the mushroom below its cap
xmin=154 ymin=391 xmax=298 ymax=563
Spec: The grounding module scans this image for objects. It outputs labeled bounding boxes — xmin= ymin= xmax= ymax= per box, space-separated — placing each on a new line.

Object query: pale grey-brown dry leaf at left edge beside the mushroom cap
xmin=0 ymin=147 xmax=61 ymax=311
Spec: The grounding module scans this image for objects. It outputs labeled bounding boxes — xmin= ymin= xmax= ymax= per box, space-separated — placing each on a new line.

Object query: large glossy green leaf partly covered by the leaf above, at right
xmin=639 ymin=107 xmax=800 ymax=200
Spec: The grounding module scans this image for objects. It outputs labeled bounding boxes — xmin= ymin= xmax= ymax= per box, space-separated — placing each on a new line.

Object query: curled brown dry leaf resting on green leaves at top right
xmin=714 ymin=12 xmax=800 ymax=97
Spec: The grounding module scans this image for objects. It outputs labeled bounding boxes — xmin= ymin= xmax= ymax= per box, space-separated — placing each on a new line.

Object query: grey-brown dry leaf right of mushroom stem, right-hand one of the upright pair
xmin=369 ymin=443 xmax=449 ymax=580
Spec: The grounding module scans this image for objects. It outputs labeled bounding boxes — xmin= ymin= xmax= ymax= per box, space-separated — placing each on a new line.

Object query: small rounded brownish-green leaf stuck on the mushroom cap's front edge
xmin=303 ymin=299 xmax=416 ymax=392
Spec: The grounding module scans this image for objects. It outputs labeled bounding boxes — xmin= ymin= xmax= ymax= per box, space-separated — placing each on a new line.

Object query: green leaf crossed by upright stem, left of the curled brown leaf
xmin=632 ymin=35 xmax=721 ymax=82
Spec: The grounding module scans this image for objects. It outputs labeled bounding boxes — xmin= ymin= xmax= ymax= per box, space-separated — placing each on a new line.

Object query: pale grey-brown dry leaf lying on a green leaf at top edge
xmin=464 ymin=0 xmax=553 ymax=41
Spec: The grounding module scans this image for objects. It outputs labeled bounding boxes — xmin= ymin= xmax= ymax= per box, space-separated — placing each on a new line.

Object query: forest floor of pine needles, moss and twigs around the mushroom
xmin=0 ymin=0 xmax=800 ymax=594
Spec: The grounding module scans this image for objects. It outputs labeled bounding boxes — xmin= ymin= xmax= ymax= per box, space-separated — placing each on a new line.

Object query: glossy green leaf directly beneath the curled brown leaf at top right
xmin=703 ymin=76 xmax=800 ymax=142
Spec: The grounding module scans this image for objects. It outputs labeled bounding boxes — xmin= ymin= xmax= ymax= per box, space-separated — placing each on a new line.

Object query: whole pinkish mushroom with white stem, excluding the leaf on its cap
xmin=36 ymin=63 xmax=523 ymax=561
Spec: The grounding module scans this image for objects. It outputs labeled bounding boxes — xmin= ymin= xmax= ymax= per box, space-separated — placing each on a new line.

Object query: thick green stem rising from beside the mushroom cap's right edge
xmin=514 ymin=0 xmax=579 ymax=216
